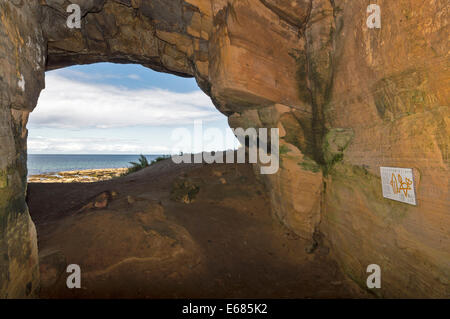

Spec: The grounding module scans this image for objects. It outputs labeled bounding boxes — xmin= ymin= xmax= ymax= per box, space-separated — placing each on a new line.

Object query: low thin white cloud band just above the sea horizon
xmin=28 ymin=136 xmax=170 ymax=154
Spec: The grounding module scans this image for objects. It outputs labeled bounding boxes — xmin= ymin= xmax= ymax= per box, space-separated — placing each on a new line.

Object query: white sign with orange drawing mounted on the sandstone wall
xmin=380 ymin=167 xmax=417 ymax=205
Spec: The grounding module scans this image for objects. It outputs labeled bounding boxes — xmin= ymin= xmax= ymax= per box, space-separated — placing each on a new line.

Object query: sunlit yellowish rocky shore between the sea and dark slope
xmin=28 ymin=168 xmax=128 ymax=183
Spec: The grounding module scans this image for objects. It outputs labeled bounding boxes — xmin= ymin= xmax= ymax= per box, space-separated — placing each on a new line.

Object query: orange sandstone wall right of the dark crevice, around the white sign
xmin=321 ymin=0 xmax=450 ymax=297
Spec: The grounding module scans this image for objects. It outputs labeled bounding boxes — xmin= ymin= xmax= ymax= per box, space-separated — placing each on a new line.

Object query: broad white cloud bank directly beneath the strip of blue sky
xmin=29 ymin=73 xmax=224 ymax=130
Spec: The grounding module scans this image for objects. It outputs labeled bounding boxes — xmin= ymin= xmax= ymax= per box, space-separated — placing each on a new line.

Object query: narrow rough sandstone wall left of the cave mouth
xmin=0 ymin=0 xmax=45 ymax=298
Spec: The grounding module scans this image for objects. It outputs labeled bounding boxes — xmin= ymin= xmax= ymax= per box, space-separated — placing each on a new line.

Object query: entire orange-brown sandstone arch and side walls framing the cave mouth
xmin=0 ymin=0 xmax=450 ymax=297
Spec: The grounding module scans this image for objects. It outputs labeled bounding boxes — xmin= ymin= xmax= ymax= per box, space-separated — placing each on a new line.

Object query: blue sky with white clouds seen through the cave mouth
xmin=28 ymin=63 xmax=238 ymax=154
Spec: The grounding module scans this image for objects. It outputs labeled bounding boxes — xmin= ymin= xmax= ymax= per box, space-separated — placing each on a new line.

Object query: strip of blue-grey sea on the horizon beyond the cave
xmin=28 ymin=154 xmax=162 ymax=176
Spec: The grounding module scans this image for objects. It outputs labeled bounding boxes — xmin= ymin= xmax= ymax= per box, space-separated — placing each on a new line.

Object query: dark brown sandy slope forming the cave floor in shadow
xmin=28 ymin=160 xmax=368 ymax=298
